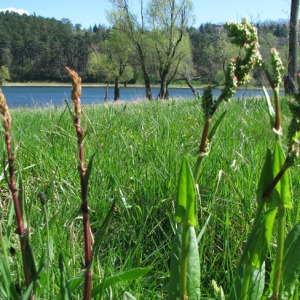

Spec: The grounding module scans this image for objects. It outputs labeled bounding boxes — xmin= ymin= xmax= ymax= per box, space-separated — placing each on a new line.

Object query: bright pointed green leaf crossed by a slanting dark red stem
xmin=273 ymin=142 xmax=293 ymax=209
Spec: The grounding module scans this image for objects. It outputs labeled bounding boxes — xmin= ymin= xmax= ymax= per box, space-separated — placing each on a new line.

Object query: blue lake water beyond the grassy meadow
xmin=1 ymin=86 xmax=272 ymax=108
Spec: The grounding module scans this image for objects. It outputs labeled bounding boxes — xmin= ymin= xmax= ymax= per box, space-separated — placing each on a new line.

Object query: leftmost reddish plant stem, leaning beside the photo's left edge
xmin=4 ymin=116 xmax=34 ymax=294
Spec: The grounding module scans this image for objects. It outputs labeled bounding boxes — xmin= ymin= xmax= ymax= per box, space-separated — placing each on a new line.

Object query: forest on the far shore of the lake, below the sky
xmin=0 ymin=12 xmax=288 ymax=85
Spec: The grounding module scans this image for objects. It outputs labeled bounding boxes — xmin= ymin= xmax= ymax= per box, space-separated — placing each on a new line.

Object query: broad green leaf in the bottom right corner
xmin=280 ymin=222 xmax=300 ymax=299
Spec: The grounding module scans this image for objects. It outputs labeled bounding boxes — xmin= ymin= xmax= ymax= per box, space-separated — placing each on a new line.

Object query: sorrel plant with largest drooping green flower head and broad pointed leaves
xmin=169 ymin=19 xmax=260 ymax=300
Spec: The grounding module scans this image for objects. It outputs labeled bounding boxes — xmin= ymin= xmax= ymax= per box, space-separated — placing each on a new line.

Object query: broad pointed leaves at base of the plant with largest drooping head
xmin=169 ymin=159 xmax=200 ymax=300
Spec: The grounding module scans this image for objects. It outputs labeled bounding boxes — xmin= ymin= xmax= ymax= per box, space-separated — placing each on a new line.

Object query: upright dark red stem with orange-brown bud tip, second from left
xmin=66 ymin=67 xmax=92 ymax=300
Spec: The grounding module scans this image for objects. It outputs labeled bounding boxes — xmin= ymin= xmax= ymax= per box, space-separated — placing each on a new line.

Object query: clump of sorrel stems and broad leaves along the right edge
xmin=230 ymin=45 xmax=300 ymax=299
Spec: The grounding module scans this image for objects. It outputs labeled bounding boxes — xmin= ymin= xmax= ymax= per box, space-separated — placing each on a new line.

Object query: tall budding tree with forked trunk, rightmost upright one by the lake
xmin=147 ymin=0 xmax=193 ymax=99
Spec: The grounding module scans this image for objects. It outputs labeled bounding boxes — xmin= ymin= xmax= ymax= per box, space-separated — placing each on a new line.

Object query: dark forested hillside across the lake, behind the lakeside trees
xmin=0 ymin=12 xmax=288 ymax=85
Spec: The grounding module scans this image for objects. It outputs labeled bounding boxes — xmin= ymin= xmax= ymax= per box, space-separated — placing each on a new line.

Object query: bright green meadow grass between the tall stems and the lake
xmin=0 ymin=95 xmax=300 ymax=299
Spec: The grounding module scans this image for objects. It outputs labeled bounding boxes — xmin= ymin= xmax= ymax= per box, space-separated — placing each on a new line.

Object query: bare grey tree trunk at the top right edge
xmin=284 ymin=0 xmax=299 ymax=94
